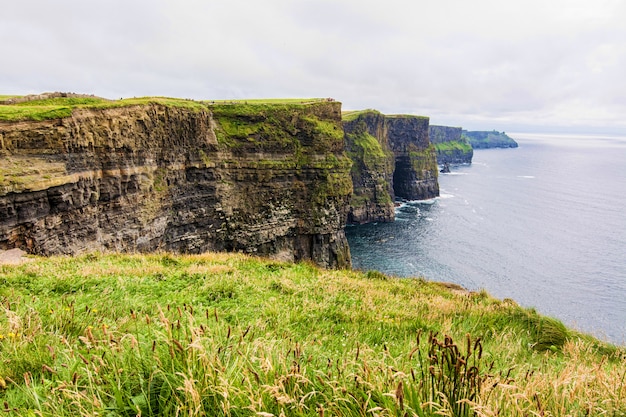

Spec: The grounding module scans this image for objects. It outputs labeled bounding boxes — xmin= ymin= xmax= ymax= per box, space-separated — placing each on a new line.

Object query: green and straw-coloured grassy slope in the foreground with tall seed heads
xmin=0 ymin=254 xmax=626 ymax=416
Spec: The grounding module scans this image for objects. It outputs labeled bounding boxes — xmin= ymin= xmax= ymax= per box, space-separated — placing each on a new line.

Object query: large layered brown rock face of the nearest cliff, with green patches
xmin=0 ymin=101 xmax=352 ymax=267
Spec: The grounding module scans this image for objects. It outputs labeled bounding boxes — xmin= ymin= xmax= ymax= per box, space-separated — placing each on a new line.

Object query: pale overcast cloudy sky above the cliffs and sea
xmin=0 ymin=0 xmax=626 ymax=136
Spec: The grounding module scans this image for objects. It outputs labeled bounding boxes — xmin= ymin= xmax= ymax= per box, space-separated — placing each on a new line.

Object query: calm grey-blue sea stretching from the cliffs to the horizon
xmin=346 ymin=134 xmax=626 ymax=345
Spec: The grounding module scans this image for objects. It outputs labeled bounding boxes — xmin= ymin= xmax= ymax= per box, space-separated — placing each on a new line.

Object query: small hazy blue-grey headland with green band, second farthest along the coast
xmin=428 ymin=125 xmax=474 ymax=165
